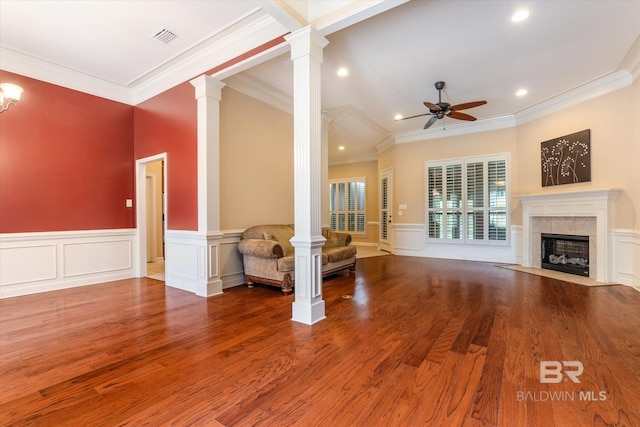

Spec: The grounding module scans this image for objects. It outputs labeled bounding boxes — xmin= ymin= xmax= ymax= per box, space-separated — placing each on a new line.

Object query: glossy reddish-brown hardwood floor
xmin=0 ymin=256 xmax=640 ymax=427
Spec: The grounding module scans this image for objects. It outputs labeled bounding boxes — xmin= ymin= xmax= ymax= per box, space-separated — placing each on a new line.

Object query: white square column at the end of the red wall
xmin=191 ymin=75 xmax=224 ymax=296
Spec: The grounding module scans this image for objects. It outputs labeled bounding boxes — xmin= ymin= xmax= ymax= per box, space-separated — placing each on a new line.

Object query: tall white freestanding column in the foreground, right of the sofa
xmin=285 ymin=27 xmax=329 ymax=325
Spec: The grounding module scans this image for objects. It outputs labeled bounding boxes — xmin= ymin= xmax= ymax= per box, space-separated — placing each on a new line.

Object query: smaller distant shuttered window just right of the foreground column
xmin=329 ymin=178 xmax=366 ymax=234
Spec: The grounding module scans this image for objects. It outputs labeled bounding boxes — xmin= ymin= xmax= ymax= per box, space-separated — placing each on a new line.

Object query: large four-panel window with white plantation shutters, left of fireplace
xmin=425 ymin=154 xmax=509 ymax=244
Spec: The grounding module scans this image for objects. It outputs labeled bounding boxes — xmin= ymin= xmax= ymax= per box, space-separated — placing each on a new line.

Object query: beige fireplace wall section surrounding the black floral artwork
xmin=512 ymin=82 xmax=640 ymax=228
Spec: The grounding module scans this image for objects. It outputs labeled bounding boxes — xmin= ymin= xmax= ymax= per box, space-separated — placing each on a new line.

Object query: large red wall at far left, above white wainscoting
xmin=0 ymin=71 xmax=135 ymax=233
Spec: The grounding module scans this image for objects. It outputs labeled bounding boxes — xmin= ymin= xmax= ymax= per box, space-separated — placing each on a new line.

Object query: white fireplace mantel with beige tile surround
xmin=517 ymin=188 xmax=619 ymax=283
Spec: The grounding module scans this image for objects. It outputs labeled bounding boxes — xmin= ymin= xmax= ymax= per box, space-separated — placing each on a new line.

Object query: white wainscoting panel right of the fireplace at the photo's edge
xmin=611 ymin=229 xmax=640 ymax=291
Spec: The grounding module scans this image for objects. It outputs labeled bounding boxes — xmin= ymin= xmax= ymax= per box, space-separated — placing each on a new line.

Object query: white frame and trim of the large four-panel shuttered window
xmin=424 ymin=152 xmax=511 ymax=246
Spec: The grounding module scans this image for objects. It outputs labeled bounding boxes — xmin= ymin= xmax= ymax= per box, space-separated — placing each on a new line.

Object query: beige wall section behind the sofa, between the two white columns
xmin=220 ymin=87 xmax=293 ymax=230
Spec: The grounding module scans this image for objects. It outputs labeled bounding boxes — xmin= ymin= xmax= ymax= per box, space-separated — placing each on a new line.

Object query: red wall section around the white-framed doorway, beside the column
xmin=134 ymin=82 xmax=198 ymax=231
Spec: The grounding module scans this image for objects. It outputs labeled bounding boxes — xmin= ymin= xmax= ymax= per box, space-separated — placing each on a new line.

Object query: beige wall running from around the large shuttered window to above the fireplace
xmin=378 ymin=81 xmax=640 ymax=229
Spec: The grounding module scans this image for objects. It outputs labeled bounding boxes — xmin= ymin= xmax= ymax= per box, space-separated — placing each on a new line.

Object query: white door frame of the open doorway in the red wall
xmin=134 ymin=153 xmax=169 ymax=277
